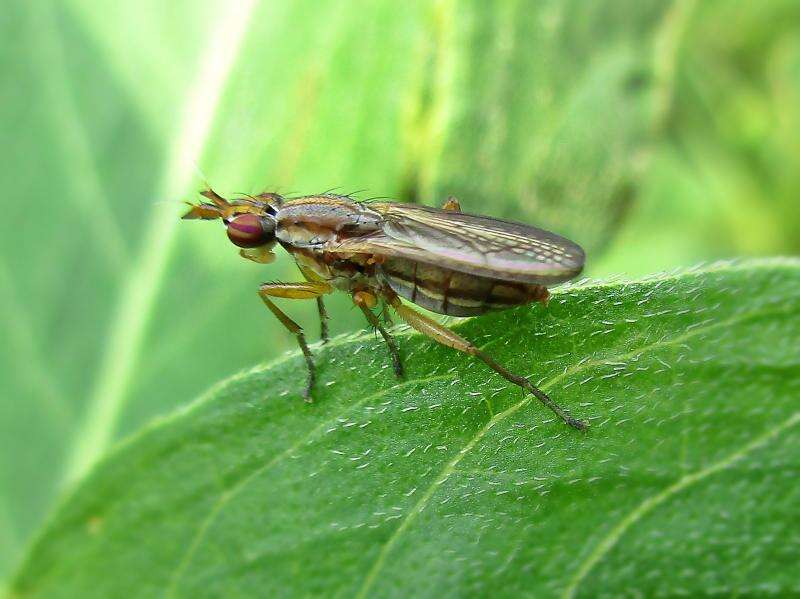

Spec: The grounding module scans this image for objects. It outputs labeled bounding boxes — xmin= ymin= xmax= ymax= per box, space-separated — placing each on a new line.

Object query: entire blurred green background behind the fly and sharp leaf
xmin=0 ymin=0 xmax=800 ymax=580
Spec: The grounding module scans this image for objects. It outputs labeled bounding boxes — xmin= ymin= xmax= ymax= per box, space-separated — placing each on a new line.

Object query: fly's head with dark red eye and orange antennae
xmin=183 ymin=189 xmax=283 ymax=263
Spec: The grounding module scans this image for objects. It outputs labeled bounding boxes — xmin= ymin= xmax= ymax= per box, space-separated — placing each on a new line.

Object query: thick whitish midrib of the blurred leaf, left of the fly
xmin=64 ymin=0 xmax=256 ymax=483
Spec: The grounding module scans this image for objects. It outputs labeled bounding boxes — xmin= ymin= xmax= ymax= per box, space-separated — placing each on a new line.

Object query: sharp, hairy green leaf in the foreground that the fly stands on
xmin=12 ymin=259 xmax=800 ymax=596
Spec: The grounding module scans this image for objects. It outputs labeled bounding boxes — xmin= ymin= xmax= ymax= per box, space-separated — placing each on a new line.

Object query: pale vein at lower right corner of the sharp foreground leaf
xmin=563 ymin=412 xmax=800 ymax=599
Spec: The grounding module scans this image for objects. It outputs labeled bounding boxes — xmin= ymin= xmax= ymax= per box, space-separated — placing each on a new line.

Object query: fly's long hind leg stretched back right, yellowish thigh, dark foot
xmin=388 ymin=294 xmax=588 ymax=431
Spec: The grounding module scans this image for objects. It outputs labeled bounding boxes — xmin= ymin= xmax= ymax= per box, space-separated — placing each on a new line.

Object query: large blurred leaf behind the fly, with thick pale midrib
xmin=0 ymin=0 xmax=666 ymax=577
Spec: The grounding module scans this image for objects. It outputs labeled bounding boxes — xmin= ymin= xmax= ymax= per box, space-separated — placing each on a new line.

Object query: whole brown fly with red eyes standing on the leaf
xmin=183 ymin=189 xmax=587 ymax=430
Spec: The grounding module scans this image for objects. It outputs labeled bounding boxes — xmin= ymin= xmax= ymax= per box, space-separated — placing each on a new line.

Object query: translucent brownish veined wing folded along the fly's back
xmin=330 ymin=202 xmax=585 ymax=285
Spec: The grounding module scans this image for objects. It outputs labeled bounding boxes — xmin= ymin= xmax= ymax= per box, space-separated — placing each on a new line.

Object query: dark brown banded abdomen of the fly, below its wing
xmin=380 ymin=258 xmax=549 ymax=316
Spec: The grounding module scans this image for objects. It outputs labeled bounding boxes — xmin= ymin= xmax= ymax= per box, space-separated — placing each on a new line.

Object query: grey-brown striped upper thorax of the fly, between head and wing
xmin=275 ymin=196 xmax=381 ymax=247
